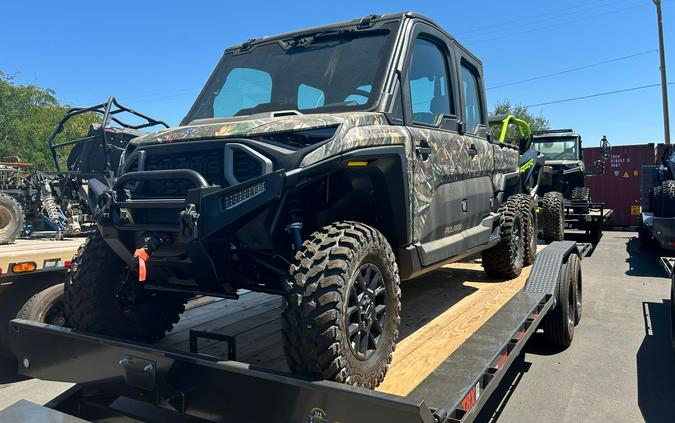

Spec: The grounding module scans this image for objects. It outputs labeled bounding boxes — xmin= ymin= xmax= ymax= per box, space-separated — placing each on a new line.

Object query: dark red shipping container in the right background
xmin=583 ymin=143 xmax=662 ymax=227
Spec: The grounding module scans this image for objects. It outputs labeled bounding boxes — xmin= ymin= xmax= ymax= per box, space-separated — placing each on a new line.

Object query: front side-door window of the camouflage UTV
xmin=408 ymin=38 xmax=452 ymax=125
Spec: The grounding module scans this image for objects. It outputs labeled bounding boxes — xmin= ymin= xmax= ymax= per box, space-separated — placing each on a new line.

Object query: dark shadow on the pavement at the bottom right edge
xmin=636 ymin=300 xmax=675 ymax=422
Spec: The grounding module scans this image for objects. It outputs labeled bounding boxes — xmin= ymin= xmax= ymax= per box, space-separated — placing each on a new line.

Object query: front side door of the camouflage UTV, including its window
xmin=404 ymin=24 xmax=475 ymax=265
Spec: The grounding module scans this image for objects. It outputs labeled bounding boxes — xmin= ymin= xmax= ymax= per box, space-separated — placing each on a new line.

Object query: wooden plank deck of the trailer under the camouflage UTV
xmin=159 ymin=263 xmax=530 ymax=396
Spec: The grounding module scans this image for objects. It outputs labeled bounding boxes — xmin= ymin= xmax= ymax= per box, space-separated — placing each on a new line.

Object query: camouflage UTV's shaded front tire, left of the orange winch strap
xmin=64 ymin=232 xmax=186 ymax=342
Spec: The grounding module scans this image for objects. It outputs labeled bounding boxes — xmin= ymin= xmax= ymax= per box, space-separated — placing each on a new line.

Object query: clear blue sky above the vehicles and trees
xmin=0 ymin=0 xmax=675 ymax=146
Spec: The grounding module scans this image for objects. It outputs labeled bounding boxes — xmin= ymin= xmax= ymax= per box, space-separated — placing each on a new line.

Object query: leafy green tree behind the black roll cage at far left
xmin=0 ymin=71 xmax=100 ymax=170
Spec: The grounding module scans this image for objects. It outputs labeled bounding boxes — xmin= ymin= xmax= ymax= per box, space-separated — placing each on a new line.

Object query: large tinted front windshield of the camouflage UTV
xmin=183 ymin=24 xmax=394 ymax=123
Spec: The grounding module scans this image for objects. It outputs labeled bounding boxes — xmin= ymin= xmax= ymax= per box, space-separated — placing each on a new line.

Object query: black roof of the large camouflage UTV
xmin=225 ymin=12 xmax=482 ymax=64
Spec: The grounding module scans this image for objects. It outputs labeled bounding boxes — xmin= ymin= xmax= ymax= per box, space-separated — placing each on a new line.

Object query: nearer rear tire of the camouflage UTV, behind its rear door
xmin=481 ymin=196 xmax=526 ymax=279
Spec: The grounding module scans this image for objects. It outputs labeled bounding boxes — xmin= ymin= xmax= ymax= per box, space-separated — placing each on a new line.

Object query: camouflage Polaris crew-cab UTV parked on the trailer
xmin=65 ymin=13 xmax=534 ymax=388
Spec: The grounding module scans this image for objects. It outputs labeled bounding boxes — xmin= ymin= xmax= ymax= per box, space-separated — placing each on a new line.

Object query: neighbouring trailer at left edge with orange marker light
xmin=0 ymin=239 xmax=84 ymax=358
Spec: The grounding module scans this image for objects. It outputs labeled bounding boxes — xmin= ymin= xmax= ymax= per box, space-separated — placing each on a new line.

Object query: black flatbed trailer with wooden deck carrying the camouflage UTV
xmin=0 ymin=241 xmax=590 ymax=422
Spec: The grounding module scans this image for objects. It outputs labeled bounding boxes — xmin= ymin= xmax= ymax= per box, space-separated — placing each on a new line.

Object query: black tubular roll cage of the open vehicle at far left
xmin=47 ymin=97 xmax=169 ymax=172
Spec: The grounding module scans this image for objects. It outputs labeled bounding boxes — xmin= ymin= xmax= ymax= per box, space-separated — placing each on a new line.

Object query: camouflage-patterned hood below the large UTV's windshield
xmin=131 ymin=114 xmax=349 ymax=147
